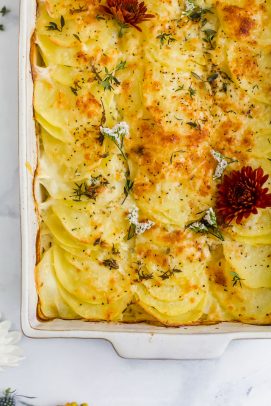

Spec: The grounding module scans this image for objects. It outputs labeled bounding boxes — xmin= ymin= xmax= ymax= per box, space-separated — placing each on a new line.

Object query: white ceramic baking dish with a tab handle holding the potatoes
xmin=19 ymin=0 xmax=271 ymax=359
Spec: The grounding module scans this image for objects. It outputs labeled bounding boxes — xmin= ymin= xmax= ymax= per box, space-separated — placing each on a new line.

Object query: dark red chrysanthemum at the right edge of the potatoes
xmin=216 ymin=166 xmax=271 ymax=224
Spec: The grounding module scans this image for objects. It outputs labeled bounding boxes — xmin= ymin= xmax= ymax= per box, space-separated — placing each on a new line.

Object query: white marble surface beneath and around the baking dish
xmin=0 ymin=0 xmax=271 ymax=406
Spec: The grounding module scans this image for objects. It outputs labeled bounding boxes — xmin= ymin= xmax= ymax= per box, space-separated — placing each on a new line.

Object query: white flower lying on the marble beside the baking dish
xmin=0 ymin=321 xmax=23 ymax=371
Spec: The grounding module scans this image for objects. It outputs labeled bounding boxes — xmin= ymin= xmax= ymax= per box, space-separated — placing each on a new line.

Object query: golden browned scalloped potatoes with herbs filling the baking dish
xmin=31 ymin=0 xmax=271 ymax=326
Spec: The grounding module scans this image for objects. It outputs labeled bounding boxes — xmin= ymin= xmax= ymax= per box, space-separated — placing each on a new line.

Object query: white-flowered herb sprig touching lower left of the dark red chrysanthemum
xmin=186 ymin=207 xmax=224 ymax=241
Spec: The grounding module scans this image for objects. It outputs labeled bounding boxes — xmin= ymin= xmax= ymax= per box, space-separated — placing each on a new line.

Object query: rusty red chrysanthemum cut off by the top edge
xmin=101 ymin=0 xmax=155 ymax=31
